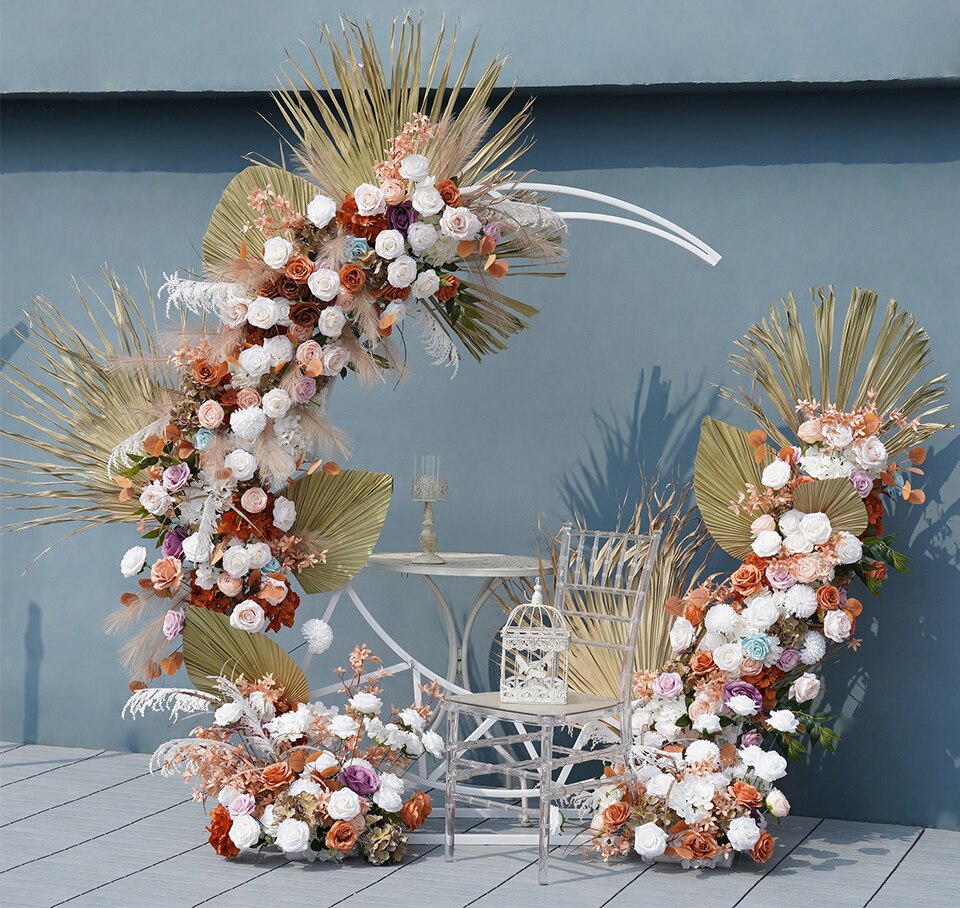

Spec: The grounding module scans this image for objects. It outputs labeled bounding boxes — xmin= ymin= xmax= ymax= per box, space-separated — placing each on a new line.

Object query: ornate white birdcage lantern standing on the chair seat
xmin=500 ymin=578 xmax=570 ymax=703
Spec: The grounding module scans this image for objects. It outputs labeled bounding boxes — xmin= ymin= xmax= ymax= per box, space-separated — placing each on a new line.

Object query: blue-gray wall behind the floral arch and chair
xmin=0 ymin=3 xmax=960 ymax=828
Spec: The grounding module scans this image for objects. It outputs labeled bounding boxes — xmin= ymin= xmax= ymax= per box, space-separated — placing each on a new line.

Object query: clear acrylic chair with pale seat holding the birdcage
xmin=444 ymin=523 xmax=660 ymax=885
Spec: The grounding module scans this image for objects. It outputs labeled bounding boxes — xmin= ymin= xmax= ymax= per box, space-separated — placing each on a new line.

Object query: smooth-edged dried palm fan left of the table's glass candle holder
xmin=283 ymin=470 xmax=393 ymax=593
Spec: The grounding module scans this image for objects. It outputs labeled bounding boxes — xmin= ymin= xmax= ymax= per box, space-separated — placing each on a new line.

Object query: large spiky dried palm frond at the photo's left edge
xmin=0 ymin=271 xmax=176 ymax=531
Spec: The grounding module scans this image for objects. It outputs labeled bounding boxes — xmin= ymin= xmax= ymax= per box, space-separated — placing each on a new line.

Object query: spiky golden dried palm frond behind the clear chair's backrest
xmin=497 ymin=477 xmax=710 ymax=697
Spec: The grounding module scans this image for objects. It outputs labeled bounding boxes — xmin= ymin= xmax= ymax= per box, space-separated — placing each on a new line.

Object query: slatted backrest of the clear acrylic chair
xmin=554 ymin=523 xmax=660 ymax=739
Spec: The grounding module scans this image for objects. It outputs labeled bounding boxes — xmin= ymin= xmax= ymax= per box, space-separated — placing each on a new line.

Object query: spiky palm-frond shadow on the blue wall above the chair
xmin=560 ymin=366 xmax=717 ymax=530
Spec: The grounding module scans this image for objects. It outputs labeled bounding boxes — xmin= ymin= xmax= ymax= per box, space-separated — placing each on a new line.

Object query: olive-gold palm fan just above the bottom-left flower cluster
xmin=183 ymin=605 xmax=310 ymax=703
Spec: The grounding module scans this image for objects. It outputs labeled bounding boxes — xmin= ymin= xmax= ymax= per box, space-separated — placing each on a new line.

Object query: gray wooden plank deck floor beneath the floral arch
xmin=0 ymin=744 xmax=960 ymax=908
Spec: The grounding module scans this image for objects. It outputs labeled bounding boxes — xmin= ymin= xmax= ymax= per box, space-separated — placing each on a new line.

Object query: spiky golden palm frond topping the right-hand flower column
xmin=721 ymin=287 xmax=951 ymax=457
